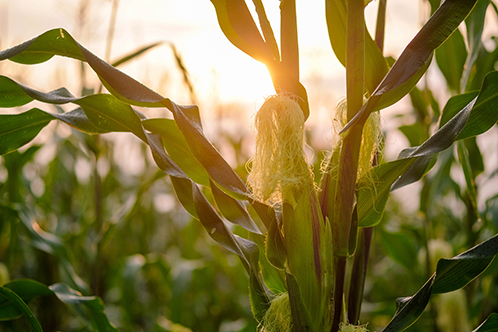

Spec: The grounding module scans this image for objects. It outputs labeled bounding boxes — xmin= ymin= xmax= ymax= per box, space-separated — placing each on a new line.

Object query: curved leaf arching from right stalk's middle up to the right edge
xmin=357 ymin=72 xmax=498 ymax=227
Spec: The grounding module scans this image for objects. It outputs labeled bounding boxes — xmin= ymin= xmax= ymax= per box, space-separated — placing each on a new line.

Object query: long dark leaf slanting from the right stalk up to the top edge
xmin=342 ymin=0 xmax=477 ymax=132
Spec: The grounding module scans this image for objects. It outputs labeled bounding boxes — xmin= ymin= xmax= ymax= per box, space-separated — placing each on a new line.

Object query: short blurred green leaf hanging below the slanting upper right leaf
xmin=436 ymin=29 xmax=467 ymax=92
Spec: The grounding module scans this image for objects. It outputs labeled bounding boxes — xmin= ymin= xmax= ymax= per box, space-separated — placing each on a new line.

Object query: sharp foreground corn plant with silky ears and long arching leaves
xmin=0 ymin=0 xmax=498 ymax=332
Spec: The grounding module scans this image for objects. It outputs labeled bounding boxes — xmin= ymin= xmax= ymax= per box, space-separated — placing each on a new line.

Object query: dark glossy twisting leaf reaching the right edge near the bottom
xmin=383 ymin=235 xmax=498 ymax=332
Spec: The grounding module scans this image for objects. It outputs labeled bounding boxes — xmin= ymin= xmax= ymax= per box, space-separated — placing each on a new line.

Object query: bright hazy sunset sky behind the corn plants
xmin=0 ymin=0 xmax=421 ymax=126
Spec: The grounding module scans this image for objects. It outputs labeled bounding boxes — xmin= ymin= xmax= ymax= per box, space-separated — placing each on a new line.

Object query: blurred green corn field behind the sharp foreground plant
xmin=0 ymin=0 xmax=498 ymax=331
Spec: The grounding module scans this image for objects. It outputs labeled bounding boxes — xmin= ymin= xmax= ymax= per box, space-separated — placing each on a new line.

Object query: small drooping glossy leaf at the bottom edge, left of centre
xmin=49 ymin=284 xmax=118 ymax=332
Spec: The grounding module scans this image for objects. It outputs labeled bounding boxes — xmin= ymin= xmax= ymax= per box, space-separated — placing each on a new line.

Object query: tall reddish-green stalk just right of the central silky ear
xmin=332 ymin=0 xmax=365 ymax=332
